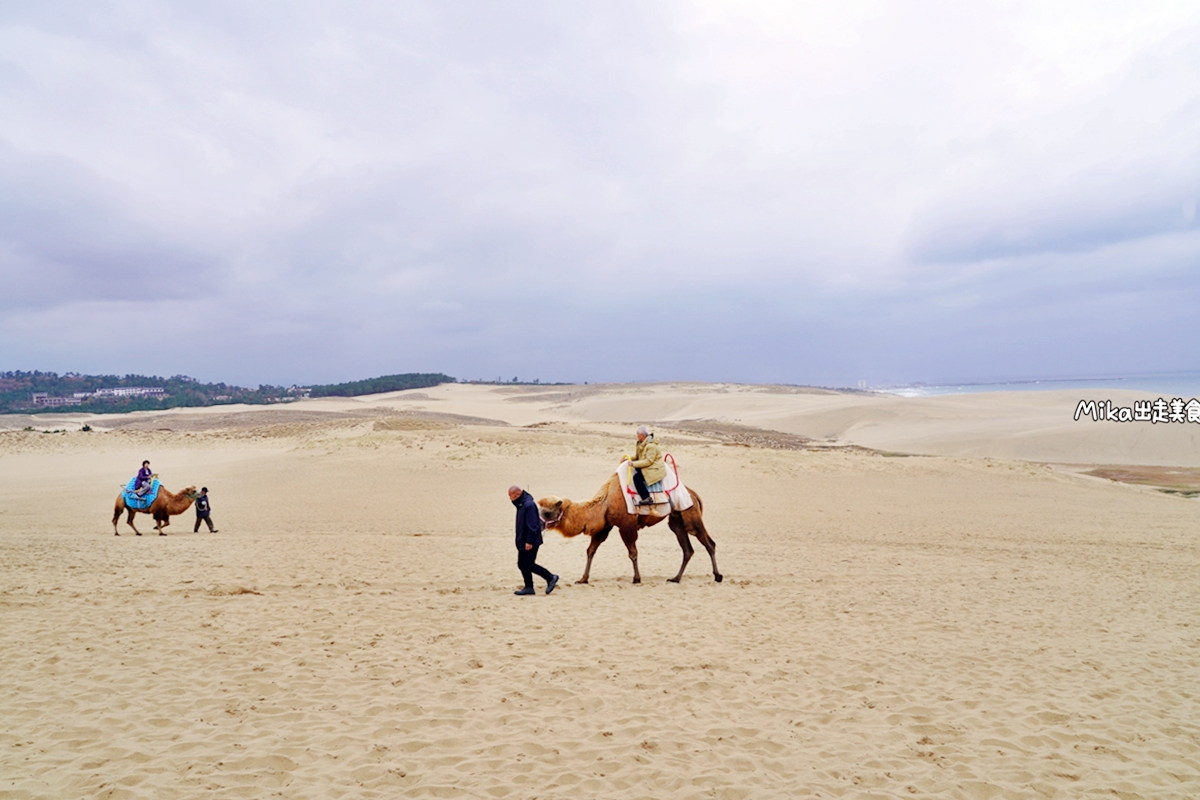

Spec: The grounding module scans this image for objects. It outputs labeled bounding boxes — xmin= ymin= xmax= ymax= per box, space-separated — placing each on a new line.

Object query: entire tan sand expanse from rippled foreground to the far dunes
xmin=0 ymin=385 xmax=1200 ymax=799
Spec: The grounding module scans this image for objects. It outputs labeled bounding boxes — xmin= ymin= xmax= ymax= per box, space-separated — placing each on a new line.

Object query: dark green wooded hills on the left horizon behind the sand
xmin=0 ymin=371 xmax=455 ymax=414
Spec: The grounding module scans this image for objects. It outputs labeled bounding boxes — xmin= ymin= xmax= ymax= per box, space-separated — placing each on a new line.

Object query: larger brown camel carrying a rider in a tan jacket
xmin=538 ymin=475 xmax=725 ymax=583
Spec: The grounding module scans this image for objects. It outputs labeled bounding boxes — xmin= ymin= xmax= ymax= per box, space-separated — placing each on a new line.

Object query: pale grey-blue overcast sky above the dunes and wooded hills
xmin=0 ymin=0 xmax=1200 ymax=386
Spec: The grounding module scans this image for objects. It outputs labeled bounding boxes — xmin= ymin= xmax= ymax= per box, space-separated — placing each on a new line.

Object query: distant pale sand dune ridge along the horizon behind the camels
xmin=14 ymin=384 xmax=1200 ymax=467
